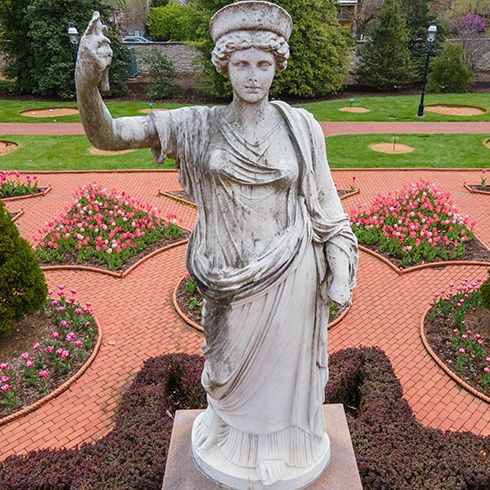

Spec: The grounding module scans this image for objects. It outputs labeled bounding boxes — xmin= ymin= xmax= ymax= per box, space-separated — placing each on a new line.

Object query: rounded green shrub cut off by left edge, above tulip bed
xmin=0 ymin=202 xmax=48 ymax=334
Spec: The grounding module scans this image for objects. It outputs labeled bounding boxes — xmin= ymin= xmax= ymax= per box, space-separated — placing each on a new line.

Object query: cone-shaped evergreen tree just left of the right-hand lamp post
xmin=357 ymin=0 xmax=414 ymax=90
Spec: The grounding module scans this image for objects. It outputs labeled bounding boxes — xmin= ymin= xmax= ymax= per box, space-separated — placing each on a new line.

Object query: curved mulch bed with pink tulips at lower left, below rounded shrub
xmin=0 ymin=285 xmax=98 ymax=418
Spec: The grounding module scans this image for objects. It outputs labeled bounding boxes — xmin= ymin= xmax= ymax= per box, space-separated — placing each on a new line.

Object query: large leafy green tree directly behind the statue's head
xmin=191 ymin=0 xmax=354 ymax=97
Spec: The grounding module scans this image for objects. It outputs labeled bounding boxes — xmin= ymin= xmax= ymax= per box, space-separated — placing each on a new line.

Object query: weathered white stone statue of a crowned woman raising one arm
xmin=76 ymin=1 xmax=358 ymax=490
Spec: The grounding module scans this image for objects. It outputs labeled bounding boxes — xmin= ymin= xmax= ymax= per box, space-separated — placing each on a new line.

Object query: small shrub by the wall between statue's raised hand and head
xmin=142 ymin=48 xmax=180 ymax=99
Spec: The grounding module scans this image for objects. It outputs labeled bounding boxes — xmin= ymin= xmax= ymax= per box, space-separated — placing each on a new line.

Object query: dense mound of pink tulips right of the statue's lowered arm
xmin=350 ymin=179 xmax=476 ymax=267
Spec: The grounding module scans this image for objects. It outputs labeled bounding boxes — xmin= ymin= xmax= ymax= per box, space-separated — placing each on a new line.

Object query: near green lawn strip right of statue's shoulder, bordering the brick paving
xmin=326 ymin=134 xmax=490 ymax=168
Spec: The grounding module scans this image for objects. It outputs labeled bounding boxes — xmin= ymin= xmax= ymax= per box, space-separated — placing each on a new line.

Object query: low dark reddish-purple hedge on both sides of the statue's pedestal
xmin=0 ymin=348 xmax=490 ymax=490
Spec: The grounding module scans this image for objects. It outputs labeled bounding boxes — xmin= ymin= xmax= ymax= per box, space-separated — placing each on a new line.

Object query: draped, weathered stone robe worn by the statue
xmin=148 ymin=102 xmax=358 ymax=467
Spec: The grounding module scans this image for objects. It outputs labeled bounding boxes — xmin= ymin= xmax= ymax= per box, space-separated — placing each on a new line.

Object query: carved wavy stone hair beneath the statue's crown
xmin=211 ymin=31 xmax=289 ymax=77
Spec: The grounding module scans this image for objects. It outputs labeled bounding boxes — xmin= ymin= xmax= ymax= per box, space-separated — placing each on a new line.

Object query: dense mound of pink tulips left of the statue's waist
xmin=34 ymin=183 xmax=182 ymax=270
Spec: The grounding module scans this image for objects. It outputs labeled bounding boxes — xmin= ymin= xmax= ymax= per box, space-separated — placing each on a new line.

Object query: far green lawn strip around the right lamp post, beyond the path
xmin=295 ymin=94 xmax=490 ymax=122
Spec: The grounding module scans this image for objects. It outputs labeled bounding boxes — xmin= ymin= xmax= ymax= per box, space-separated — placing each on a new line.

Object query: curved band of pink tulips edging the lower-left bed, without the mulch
xmin=0 ymin=285 xmax=94 ymax=407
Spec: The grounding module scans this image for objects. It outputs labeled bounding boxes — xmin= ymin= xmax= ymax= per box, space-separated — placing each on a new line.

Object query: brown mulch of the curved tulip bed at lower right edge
xmin=424 ymin=307 xmax=490 ymax=396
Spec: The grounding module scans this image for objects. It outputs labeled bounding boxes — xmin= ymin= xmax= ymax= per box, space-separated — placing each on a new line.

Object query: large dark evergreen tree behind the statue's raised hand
xmin=0 ymin=0 xmax=129 ymax=99
